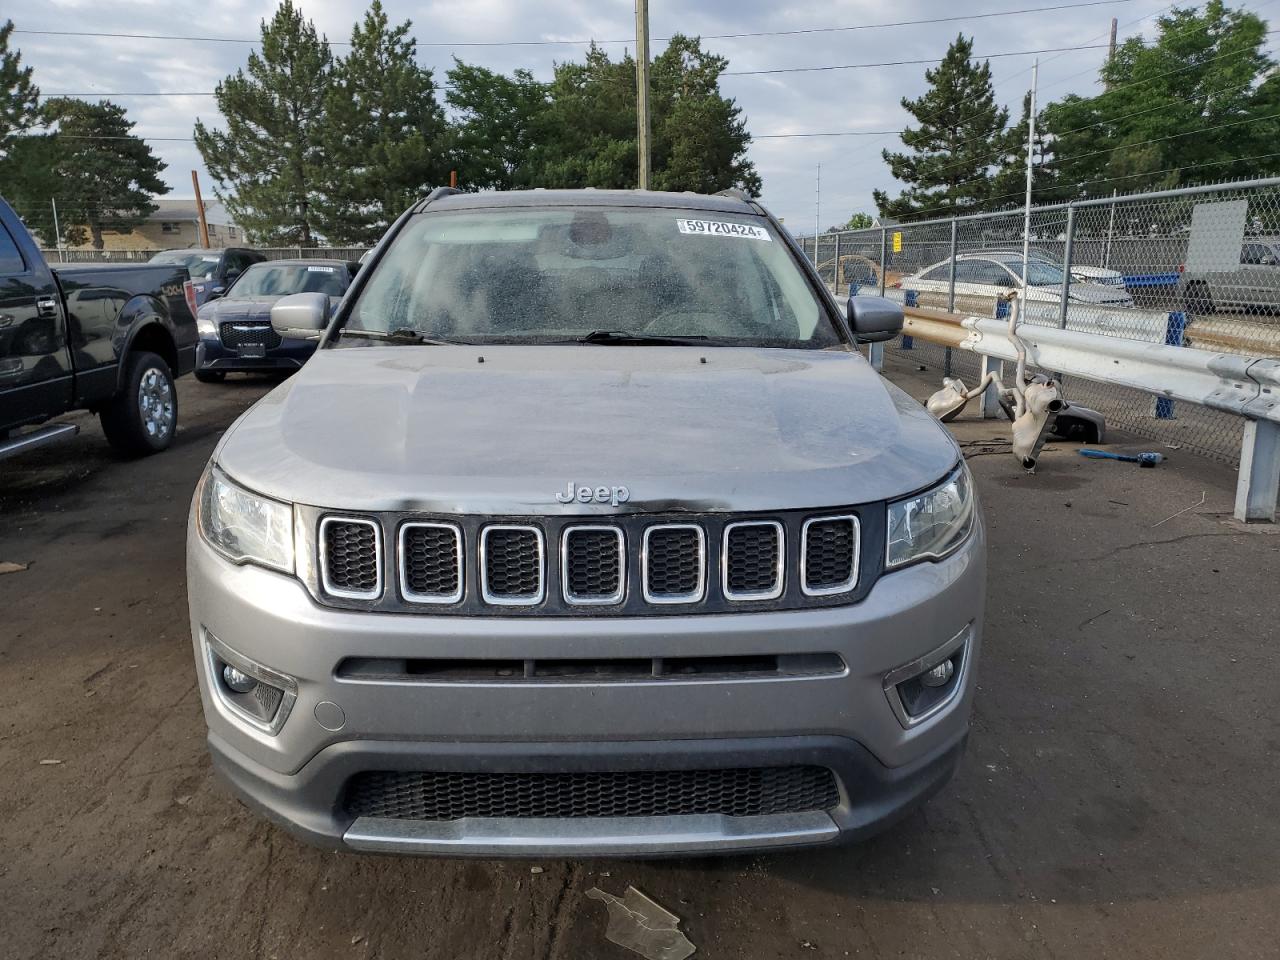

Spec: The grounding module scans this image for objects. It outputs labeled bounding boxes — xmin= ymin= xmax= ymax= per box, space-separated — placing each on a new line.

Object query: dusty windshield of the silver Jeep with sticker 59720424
xmin=343 ymin=207 xmax=844 ymax=348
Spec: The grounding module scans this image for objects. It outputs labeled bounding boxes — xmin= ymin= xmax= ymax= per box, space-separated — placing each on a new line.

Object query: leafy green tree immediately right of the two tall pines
xmin=448 ymin=59 xmax=548 ymax=189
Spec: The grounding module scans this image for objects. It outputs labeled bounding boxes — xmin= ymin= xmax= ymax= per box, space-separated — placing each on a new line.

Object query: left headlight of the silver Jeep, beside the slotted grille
xmin=198 ymin=466 xmax=293 ymax=573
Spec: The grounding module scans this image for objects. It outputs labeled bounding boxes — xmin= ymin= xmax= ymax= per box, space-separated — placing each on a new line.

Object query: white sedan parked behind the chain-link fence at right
xmin=897 ymin=251 xmax=1133 ymax=314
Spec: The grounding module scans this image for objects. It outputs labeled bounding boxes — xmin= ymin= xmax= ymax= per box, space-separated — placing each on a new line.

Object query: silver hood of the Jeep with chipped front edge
xmin=214 ymin=344 xmax=957 ymax=515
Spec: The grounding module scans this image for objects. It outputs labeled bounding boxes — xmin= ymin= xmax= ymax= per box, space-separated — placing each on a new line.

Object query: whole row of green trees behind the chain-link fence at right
xmin=850 ymin=0 xmax=1280 ymax=225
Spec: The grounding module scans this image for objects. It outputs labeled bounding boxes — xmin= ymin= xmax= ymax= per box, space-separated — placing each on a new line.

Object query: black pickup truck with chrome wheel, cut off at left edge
xmin=0 ymin=200 xmax=197 ymax=458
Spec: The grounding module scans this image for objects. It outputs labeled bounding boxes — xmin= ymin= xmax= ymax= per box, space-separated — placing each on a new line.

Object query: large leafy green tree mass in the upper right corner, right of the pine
xmin=1044 ymin=0 xmax=1280 ymax=196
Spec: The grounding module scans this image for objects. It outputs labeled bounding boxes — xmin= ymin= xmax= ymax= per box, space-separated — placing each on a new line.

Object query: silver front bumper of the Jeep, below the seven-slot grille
xmin=188 ymin=526 xmax=986 ymax=856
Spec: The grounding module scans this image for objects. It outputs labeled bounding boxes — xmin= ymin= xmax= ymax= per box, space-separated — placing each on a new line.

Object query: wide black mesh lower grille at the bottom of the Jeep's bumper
xmin=346 ymin=765 xmax=840 ymax=820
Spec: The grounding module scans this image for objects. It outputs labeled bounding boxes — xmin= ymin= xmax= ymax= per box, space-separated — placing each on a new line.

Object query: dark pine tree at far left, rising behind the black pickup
xmin=33 ymin=97 xmax=169 ymax=250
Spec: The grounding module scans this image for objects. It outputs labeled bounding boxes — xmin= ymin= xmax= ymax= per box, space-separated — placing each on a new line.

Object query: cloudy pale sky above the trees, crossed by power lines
xmin=9 ymin=0 xmax=1187 ymax=233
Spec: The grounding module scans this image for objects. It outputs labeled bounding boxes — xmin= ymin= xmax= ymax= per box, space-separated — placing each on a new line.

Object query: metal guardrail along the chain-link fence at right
xmin=902 ymin=306 xmax=1280 ymax=522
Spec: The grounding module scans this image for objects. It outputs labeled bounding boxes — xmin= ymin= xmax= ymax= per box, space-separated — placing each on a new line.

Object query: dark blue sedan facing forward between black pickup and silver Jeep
xmin=196 ymin=260 xmax=360 ymax=383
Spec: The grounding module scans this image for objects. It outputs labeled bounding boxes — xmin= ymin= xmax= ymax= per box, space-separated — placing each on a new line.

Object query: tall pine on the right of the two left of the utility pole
xmin=315 ymin=0 xmax=449 ymax=243
